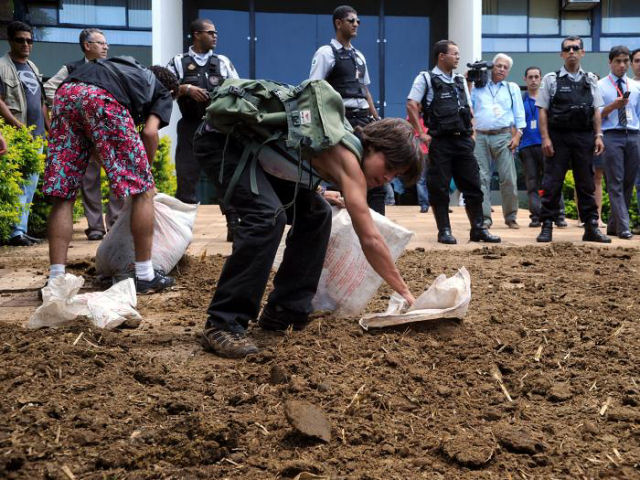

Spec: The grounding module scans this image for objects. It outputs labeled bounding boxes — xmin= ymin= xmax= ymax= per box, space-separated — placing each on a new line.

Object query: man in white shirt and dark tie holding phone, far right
xmin=598 ymin=45 xmax=640 ymax=240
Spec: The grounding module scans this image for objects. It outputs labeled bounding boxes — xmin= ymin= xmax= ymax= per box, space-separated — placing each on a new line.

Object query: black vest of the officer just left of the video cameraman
xmin=422 ymin=75 xmax=473 ymax=137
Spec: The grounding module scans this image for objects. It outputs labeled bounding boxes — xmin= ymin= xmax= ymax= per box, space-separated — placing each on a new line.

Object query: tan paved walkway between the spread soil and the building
xmin=0 ymin=205 xmax=640 ymax=292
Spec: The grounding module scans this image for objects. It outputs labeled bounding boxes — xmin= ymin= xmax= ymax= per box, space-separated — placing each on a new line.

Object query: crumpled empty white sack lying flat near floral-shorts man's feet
xmin=25 ymin=273 xmax=142 ymax=329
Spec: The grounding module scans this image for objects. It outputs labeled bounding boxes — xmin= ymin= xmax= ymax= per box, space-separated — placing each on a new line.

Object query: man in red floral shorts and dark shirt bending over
xmin=42 ymin=57 xmax=178 ymax=293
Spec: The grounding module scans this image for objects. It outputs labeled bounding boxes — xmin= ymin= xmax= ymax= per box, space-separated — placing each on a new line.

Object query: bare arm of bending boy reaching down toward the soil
xmin=328 ymin=145 xmax=415 ymax=304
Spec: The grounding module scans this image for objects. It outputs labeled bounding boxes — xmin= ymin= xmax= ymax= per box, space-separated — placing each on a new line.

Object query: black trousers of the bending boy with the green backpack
xmin=194 ymin=132 xmax=331 ymax=332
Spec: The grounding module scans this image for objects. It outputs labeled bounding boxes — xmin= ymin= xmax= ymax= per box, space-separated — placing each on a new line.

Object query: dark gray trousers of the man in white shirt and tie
xmin=604 ymin=130 xmax=640 ymax=235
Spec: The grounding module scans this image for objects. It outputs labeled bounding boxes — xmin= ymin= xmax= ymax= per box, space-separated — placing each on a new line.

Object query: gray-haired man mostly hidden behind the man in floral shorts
xmin=44 ymin=28 xmax=123 ymax=240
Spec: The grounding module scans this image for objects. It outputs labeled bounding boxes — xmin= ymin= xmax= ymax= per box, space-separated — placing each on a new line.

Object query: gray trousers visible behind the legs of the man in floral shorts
xmin=81 ymin=157 xmax=124 ymax=235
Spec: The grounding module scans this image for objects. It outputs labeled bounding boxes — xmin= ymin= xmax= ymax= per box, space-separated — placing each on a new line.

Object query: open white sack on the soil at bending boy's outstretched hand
xmin=359 ymin=267 xmax=471 ymax=330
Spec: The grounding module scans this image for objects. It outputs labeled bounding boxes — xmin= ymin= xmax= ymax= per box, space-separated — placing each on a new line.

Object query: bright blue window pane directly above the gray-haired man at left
xmin=60 ymin=0 xmax=127 ymax=27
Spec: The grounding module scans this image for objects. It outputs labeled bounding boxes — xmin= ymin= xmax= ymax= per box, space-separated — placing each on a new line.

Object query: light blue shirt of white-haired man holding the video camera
xmin=471 ymin=80 xmax=526 ymax=130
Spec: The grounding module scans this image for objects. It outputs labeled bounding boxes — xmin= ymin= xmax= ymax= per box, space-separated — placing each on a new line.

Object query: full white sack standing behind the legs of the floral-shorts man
xmin=96 ymin=193 xmax=198 ymax=277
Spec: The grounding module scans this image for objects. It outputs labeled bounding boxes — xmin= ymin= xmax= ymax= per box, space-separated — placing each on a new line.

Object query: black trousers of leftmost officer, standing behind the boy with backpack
xmin=176 ymin=118 xmax=200 ymax=203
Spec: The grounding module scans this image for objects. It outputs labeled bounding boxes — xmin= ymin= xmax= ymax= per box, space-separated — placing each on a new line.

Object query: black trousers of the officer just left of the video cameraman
xmin=427 ymin=135 xmax=483 ymax=207
